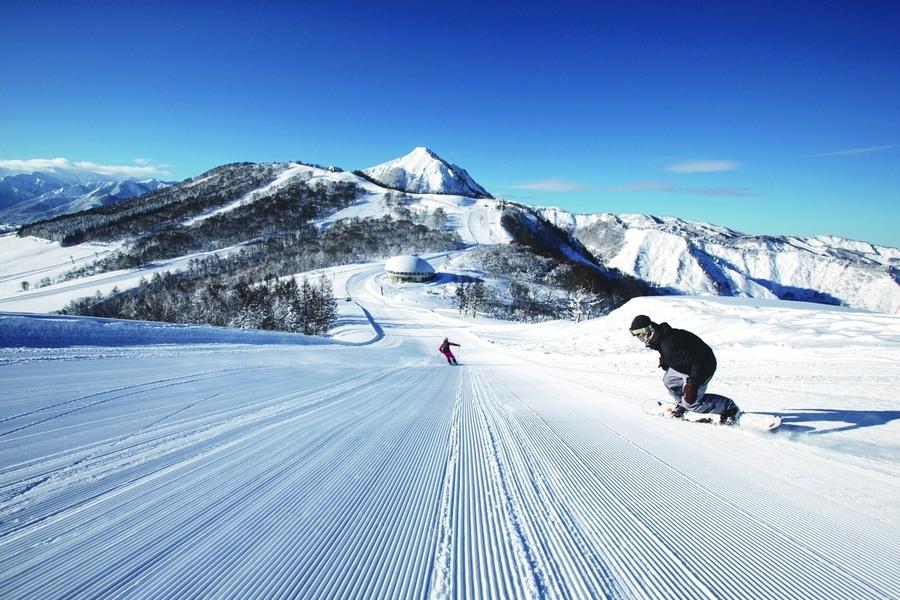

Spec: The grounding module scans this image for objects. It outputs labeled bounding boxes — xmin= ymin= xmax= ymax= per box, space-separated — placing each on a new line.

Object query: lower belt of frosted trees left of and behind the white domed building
xmin=64 ymin=216 xmax=462 ymax=334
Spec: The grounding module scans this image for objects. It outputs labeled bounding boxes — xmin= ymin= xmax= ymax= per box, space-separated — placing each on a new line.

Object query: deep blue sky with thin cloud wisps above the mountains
xmin=0 ymin=0 xmax=900 ymax=246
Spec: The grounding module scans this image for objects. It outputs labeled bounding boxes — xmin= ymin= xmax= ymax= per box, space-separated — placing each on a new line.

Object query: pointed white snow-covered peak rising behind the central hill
xmin=363 ymin=147 xmax=492 ymax=198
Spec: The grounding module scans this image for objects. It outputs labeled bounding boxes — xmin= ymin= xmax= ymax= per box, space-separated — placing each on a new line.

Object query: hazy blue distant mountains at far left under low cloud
xmin=0 ymin=169 xmax=169 ymax=225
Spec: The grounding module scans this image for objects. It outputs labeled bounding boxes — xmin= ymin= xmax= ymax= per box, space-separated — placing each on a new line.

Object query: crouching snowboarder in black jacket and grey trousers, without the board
xmin=631 ymin=315 xmax=739 ymax=425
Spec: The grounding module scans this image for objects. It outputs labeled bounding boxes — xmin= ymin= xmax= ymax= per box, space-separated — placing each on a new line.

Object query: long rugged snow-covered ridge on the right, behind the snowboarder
xmin=541 ymin=208 xmax=900 ymax=313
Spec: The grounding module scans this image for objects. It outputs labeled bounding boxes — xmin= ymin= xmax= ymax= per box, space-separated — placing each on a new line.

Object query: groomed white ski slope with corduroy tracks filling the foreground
xmin=0 ymin=266 xmax=900 ymax=599
